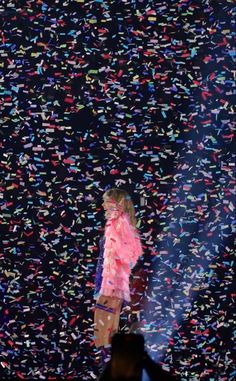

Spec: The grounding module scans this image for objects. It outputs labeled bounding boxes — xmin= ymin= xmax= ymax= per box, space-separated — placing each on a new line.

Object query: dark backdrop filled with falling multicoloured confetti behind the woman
xmin=0 ymin=0 xmax=235 ymax=381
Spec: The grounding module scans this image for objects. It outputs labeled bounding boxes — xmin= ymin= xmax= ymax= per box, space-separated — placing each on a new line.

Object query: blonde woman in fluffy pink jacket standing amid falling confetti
xmin=94 ymin=188 xmax=142 ymax=348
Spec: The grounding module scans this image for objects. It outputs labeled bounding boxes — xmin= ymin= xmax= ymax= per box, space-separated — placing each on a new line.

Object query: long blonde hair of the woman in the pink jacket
xmin=103 ymin=188 xmax=137 ymax=227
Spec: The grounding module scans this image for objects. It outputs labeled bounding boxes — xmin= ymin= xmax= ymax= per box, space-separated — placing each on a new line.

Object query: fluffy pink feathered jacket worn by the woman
xmin=100 ymin=211 xmax=143 ymax=302
